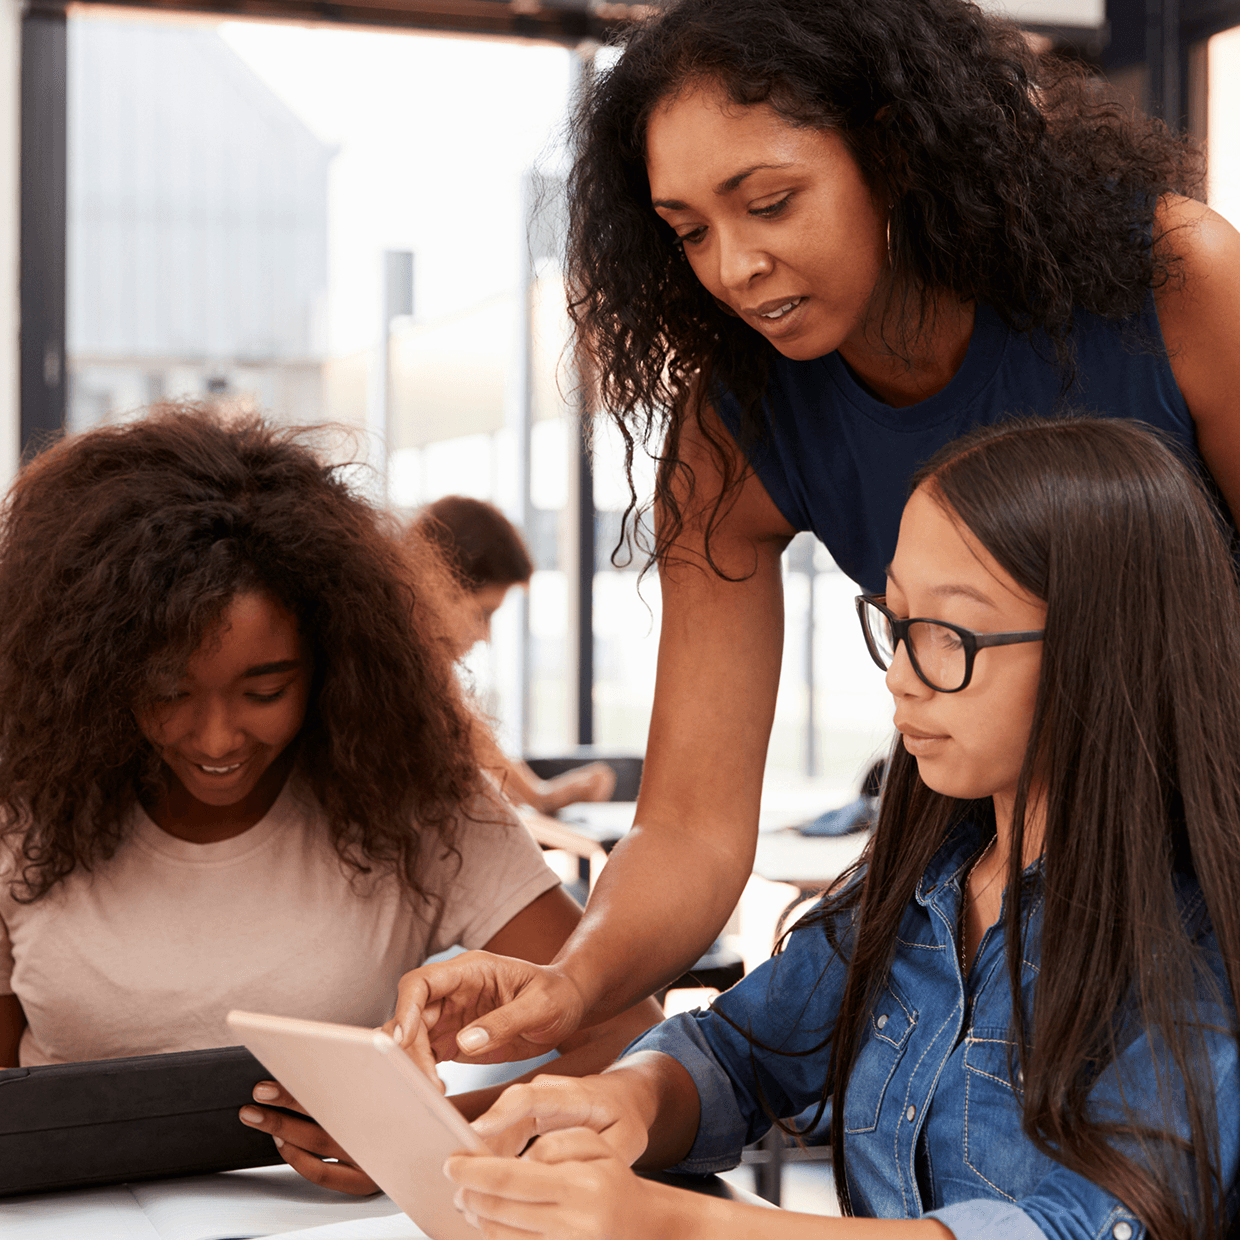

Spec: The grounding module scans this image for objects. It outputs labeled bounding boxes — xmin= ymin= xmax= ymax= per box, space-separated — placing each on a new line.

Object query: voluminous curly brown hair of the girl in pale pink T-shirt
xmin=0 ymin=405 xmax=480 ymax=900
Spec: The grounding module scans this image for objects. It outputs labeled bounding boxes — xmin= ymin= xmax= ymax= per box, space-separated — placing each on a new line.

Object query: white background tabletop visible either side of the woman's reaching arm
xmin=559 ymin=797 xmax=869 ymax=890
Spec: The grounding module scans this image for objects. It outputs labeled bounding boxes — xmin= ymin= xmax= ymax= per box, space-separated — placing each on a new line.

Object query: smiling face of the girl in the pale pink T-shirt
xmin=138 ymin=591 xmax=310 ymax=806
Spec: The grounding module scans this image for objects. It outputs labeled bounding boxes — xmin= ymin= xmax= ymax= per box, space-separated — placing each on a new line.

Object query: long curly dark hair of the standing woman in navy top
xmin=568 ymin=0 xmax=1200 ymax=559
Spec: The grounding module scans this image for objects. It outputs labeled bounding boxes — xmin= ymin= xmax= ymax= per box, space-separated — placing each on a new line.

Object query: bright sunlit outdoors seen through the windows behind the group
xmin=67 ymin=14 xmax=890 ymax=805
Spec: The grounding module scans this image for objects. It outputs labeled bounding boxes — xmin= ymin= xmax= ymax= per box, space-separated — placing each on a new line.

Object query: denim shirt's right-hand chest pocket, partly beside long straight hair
xmin=965 ymin=1027 xmax=1054 ymax=1202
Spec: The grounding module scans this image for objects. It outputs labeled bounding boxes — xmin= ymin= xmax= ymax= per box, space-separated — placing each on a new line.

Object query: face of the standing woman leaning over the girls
xmin=646 ymin=80 xmax=888 ymax=361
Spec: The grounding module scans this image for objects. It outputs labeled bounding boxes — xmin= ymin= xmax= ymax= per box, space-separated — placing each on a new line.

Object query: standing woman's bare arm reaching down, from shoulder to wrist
xmin=545 ymin=411 xmax=795 ymax=1016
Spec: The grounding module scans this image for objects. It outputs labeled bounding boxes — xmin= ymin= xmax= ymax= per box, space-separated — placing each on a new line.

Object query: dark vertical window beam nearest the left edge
xmin=20 ymin=7 xmax=68 ymax=454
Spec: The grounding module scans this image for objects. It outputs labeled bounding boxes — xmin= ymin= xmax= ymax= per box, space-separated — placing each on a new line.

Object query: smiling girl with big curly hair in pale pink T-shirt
xmin=0 ymin=407 xmax=657 ymax=1192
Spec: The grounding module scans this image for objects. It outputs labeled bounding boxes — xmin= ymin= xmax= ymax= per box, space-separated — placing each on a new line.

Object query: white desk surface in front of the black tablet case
xmin=0 ymin=1167 xmax=399 ymax=1240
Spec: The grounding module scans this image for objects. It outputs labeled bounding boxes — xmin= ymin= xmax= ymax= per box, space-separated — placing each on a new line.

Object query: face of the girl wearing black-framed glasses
xmin=887 ymin=487 xmax=1047 ymax=812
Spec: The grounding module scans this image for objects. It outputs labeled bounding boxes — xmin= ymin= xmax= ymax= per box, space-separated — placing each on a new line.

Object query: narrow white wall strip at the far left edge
xmin=0 ymin=0 xmax=21 ymax=492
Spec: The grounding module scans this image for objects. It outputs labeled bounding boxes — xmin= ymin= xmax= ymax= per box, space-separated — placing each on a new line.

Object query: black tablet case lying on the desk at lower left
xmin=0 ymin=1047 xmax=281 ymax=1197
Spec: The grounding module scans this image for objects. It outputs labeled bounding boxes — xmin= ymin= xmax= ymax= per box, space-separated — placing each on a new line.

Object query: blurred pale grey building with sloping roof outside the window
xmin=66 ymin=17 xmax=334 ymax=430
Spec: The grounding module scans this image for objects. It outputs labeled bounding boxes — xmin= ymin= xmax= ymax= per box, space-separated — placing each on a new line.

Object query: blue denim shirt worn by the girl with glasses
xmin=626 ymin=826 xmax=1240 ymax=1240
